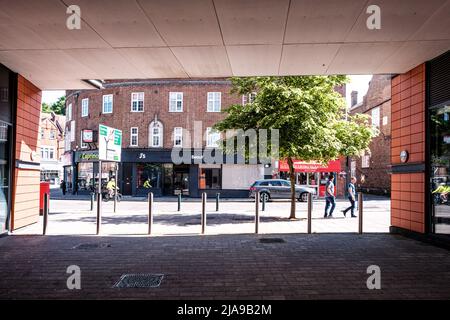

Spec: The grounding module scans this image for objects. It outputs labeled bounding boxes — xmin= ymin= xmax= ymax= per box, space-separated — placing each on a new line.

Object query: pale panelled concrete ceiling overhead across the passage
xmin=0 ymin=0 xmax=450 ymax=89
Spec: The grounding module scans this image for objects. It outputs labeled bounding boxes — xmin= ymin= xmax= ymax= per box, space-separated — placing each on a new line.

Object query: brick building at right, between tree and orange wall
xmin=347 ymin=75 xmax=391 ymax=195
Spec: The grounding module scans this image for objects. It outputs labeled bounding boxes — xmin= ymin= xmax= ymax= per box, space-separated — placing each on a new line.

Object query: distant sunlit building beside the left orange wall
xmin=39 ymin=113 xmax=66 ymax=186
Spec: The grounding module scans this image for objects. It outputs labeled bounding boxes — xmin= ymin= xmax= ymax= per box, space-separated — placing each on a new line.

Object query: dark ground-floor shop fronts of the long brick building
xmin=72 ymin=149 xmax=264 ymax=198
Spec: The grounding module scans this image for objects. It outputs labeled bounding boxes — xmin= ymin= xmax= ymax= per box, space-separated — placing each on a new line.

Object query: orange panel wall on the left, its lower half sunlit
xmin=11 ymin=75 xmax=41 ymax=230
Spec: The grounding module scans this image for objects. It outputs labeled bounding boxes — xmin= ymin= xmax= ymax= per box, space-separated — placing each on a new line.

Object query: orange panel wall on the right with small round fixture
xmin=391 ymin=64 xmax=425 ymax=233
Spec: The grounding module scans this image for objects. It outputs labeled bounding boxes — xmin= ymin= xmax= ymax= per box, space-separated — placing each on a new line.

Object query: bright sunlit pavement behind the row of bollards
xmin=15 ymin=197 xmax=390 ymax=235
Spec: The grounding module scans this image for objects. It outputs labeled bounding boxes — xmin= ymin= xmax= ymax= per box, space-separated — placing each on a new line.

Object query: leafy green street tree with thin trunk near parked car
xmin=214 ymin=75 xmax=378 ymax=219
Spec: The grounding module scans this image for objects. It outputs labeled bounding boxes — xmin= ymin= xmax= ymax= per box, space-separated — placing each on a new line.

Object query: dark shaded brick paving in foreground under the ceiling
xmin=0 ymin=234 xmax=450 ymax=299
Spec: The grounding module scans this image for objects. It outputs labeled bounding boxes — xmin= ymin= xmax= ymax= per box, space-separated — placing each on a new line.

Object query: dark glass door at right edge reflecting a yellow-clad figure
xmin=430 ymin=104 xmax=450 ymax=234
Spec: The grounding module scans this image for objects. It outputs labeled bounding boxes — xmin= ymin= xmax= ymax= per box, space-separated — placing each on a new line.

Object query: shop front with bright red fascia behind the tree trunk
xmin=278 ymin=160 xmax=345 ymax=197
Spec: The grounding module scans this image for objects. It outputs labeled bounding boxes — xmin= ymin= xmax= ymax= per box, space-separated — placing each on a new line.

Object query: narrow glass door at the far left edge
xmin=0 ymin=121 xmax=10 ymax=233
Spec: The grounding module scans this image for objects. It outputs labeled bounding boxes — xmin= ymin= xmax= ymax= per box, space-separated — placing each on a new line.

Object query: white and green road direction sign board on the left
xmin=98 ymin=124 xmax=122 ymax=162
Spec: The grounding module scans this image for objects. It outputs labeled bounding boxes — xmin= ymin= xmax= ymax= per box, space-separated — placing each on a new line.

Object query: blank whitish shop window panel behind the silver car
xmin=222 ymin=164 xmax=264 ymax=189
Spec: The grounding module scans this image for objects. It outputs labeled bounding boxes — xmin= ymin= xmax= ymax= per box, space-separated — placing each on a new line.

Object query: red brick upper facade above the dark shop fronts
xmin=66 ymin=79 xmax=242 ymax=149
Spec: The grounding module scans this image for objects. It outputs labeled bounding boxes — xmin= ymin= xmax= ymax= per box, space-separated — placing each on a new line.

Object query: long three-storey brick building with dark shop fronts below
xmin=64 ymin=79 xmax=271 ymax=197
